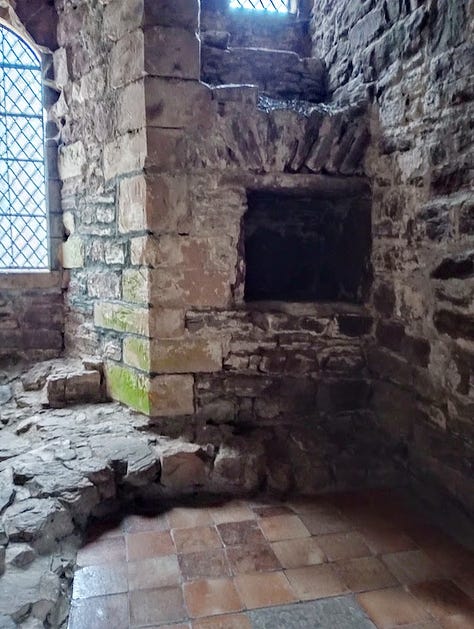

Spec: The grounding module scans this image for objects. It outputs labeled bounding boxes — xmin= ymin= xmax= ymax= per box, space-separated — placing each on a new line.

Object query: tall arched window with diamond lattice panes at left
xmin=0 ymin=24 xmax=49 ymax=271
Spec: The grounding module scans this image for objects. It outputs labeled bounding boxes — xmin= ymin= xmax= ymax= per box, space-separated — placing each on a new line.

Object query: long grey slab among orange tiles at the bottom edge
xmin=248 ymin=596 xmax=375 ymax=629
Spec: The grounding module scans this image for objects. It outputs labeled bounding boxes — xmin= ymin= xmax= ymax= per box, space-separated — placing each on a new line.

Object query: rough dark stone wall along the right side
xmin=313 ymin=0 xmax=474 ymax=513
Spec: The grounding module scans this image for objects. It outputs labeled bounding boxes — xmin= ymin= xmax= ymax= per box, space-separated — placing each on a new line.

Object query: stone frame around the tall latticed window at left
xmin=0 ymin=14 xmax=64 ymax=278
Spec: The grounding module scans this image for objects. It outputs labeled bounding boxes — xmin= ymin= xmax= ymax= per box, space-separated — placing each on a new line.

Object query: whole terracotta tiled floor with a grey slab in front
xmin=69 ymin=491 xmax=474 ymax=629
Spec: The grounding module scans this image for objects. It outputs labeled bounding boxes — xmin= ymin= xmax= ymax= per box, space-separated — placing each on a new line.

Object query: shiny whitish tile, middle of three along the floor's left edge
xmin=72 ymin=563 xmax=128 ymax=599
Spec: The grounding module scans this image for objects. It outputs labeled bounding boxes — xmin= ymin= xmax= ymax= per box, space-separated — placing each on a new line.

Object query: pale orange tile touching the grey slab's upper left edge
xmin=235 ymin=572 xmax=298 ymax=609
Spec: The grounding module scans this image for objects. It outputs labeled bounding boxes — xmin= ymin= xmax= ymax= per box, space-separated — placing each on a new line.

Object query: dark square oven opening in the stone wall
xmin=243 ymin=191 xmax=371 ymax=303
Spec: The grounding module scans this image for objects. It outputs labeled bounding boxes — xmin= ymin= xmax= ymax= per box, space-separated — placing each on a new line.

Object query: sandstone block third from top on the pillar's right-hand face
xmin=145 ymin=77 xmax=212 ymax=129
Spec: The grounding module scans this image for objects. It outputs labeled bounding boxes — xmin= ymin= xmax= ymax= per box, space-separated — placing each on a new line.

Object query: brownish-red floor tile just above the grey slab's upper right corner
xmin=337 ymin=557 xmax=398 ymax=592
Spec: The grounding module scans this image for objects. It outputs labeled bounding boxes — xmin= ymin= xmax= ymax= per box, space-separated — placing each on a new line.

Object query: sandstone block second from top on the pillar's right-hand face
xmin=145 ymin=26 xmax=201 ymax=81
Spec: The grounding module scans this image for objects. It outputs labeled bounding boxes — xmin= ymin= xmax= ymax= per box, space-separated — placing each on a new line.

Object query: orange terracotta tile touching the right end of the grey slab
xmin=357 ymin=587 xmax=430 ymax=629
